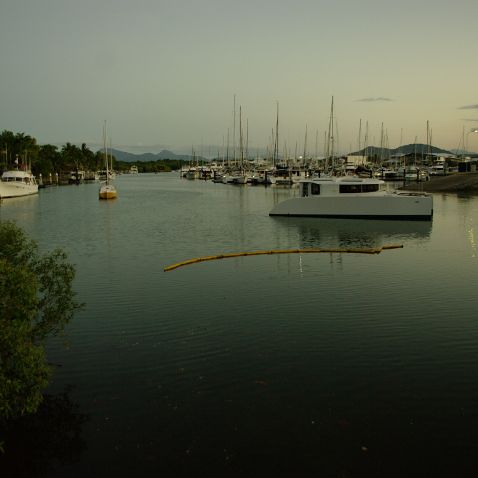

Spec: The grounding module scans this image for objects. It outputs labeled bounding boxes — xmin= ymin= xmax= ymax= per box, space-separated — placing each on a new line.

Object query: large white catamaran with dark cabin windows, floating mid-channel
xmin=269 ymin=176 xmax=433 ymax=220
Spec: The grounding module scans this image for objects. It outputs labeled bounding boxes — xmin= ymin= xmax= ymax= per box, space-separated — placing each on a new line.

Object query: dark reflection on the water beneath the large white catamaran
xmin=274 ymin=217 xmax=432 ymax=248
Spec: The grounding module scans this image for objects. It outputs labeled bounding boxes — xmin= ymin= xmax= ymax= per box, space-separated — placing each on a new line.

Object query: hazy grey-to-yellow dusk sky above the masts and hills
xmin=0 ymin=0 xmax=478 ymax=155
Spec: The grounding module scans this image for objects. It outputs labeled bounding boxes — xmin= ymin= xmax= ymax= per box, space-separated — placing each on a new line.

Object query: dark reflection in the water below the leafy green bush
xmin=0 ymin=388 xmax=87 ymax=478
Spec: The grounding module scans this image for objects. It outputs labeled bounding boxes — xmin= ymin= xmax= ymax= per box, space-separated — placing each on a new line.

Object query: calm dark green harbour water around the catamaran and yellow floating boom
xmin=0 ymin=173 xmax=478 ymax=477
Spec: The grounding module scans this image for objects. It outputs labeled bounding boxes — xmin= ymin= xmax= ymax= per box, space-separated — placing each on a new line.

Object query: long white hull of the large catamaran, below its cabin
xmin=269 ymin=193 xmax=433 ymax=221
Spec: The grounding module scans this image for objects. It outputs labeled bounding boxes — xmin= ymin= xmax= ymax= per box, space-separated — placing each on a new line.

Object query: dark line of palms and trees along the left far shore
xmin=0 ymin=130 xmax=181 ymax=177
